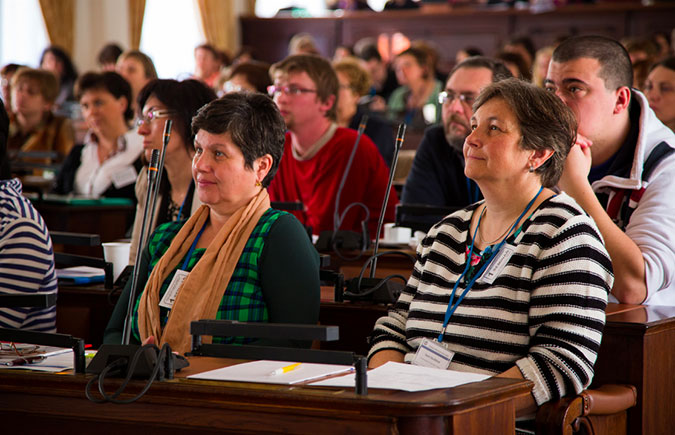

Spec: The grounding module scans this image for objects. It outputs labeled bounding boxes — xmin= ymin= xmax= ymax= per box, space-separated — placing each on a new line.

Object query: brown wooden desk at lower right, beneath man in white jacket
xmin=593 ymin=305 xmax=675 ymax=435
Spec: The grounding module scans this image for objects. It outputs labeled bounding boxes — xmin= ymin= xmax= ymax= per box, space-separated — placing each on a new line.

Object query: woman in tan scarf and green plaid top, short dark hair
xmin=104 ymin=93 xmax=320 ymax=353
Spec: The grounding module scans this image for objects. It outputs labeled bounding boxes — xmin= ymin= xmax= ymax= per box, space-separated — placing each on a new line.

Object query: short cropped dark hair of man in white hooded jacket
xmin=551 ymin=35 xmax=633 ymax=91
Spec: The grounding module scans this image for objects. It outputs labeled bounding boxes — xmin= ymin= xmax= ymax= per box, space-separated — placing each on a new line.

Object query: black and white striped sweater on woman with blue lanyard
xmin=369 ymin=193 xmax=614 ymax=405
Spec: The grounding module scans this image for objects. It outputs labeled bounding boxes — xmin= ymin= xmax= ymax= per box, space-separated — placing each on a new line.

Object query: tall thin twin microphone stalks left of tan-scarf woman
xmin=122 ymin=119 xmax=172 ymax=345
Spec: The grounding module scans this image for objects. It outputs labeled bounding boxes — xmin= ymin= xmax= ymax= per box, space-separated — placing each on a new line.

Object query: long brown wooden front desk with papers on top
xmin=0 ymin=358 xmax=531 ymax=435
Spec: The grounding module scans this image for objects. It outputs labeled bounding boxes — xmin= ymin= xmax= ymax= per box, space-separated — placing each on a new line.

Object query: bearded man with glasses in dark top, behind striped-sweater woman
xmin=402 ymin=56 xmax=512 ymax=207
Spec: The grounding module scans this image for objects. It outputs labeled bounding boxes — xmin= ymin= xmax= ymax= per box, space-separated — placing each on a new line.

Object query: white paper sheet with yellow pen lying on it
xmin=188 ymin=360 xmax=353 ymax=385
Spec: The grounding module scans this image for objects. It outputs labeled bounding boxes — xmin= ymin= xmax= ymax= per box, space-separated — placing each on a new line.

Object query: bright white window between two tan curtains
xmin=140 ymin=0 xmax=204 ymax=80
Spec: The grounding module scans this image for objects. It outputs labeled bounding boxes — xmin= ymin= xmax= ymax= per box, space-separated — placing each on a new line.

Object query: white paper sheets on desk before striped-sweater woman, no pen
xmin=311 ymin=362 xmax=491 ymax=391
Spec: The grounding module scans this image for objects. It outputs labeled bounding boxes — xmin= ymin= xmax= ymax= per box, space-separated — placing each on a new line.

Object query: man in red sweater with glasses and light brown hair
xmin=268 ymin=55 xmax=398 ymax=238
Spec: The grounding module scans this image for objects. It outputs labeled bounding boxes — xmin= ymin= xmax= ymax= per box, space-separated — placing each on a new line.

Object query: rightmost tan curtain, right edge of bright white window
xmin=197 ymin=0 xmax=239 ymax=55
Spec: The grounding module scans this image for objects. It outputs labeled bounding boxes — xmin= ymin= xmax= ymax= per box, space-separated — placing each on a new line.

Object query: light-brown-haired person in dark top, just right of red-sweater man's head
xmin=333 ymin=58 xmax=394 ymax=167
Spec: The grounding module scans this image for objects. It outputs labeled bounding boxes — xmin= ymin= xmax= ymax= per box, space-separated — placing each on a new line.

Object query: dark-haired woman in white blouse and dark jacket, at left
xmin=55 ymin=71 xmax=143 ymax=201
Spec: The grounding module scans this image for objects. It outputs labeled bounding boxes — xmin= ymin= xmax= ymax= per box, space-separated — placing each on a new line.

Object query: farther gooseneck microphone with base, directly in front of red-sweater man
xmin=316 ymin=115 xmax=370 ymax=260
